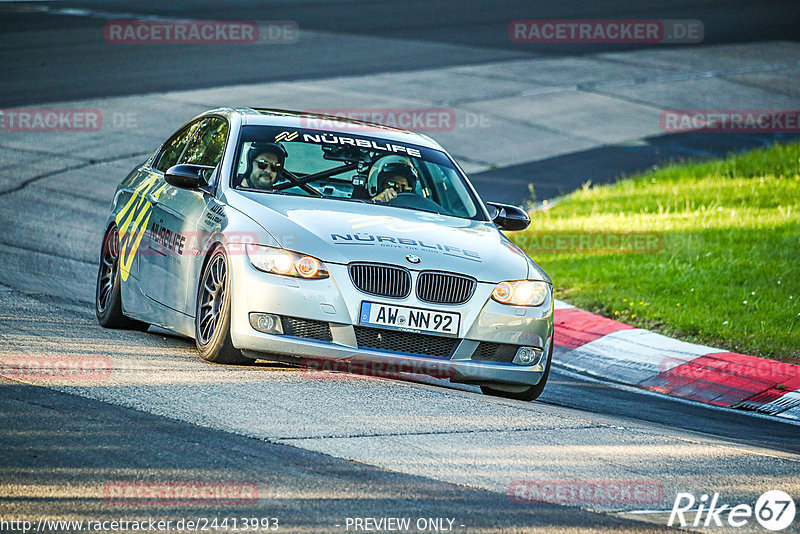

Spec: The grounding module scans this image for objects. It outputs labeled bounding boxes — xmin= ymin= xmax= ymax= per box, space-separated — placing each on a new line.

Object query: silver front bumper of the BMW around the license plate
xmin=230 ymin=255 xmax=553 ymax=386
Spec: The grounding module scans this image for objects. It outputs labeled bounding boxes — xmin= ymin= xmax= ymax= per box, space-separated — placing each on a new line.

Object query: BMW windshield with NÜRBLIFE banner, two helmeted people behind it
xmin=231 ymin=126 xmax=480 ymax=219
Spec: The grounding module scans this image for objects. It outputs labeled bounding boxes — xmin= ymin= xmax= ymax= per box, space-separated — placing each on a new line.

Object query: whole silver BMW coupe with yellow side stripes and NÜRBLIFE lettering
xmin=96 ymin=108 xmax=553 ymax=400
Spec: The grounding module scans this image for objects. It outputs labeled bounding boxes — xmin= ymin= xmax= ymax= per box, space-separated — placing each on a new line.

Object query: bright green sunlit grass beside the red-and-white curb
xmin=511 ymin=144 xmax=800 ymax=362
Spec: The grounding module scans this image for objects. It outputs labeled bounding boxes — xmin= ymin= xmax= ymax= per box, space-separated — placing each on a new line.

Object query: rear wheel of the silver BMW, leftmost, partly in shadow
xmin=94 ymin=226 xmax=150 ymax=330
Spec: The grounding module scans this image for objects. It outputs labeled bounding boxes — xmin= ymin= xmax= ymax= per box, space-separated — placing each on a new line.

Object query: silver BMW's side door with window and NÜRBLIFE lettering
xmin=147 ymin=117 xmax=229 ymax=315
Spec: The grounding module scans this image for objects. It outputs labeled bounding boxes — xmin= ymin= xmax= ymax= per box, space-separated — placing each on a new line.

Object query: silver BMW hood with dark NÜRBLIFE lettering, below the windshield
xmin=226 ymin=191 xmax=549 ymax=282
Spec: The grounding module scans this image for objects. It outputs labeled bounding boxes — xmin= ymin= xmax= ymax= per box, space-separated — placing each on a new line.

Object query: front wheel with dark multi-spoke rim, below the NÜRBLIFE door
xmin=194 ymin=248 xmax=254 ymax=365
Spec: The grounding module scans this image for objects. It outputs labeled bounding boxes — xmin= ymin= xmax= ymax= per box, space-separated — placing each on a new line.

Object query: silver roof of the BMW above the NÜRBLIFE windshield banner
xmin=207 ymin=108 xmax=444 ymax=151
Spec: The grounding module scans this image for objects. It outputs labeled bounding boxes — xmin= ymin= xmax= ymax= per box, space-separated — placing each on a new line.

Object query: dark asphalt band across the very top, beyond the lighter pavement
xmin=0 ymin=0 xmax=800 ymax=106
